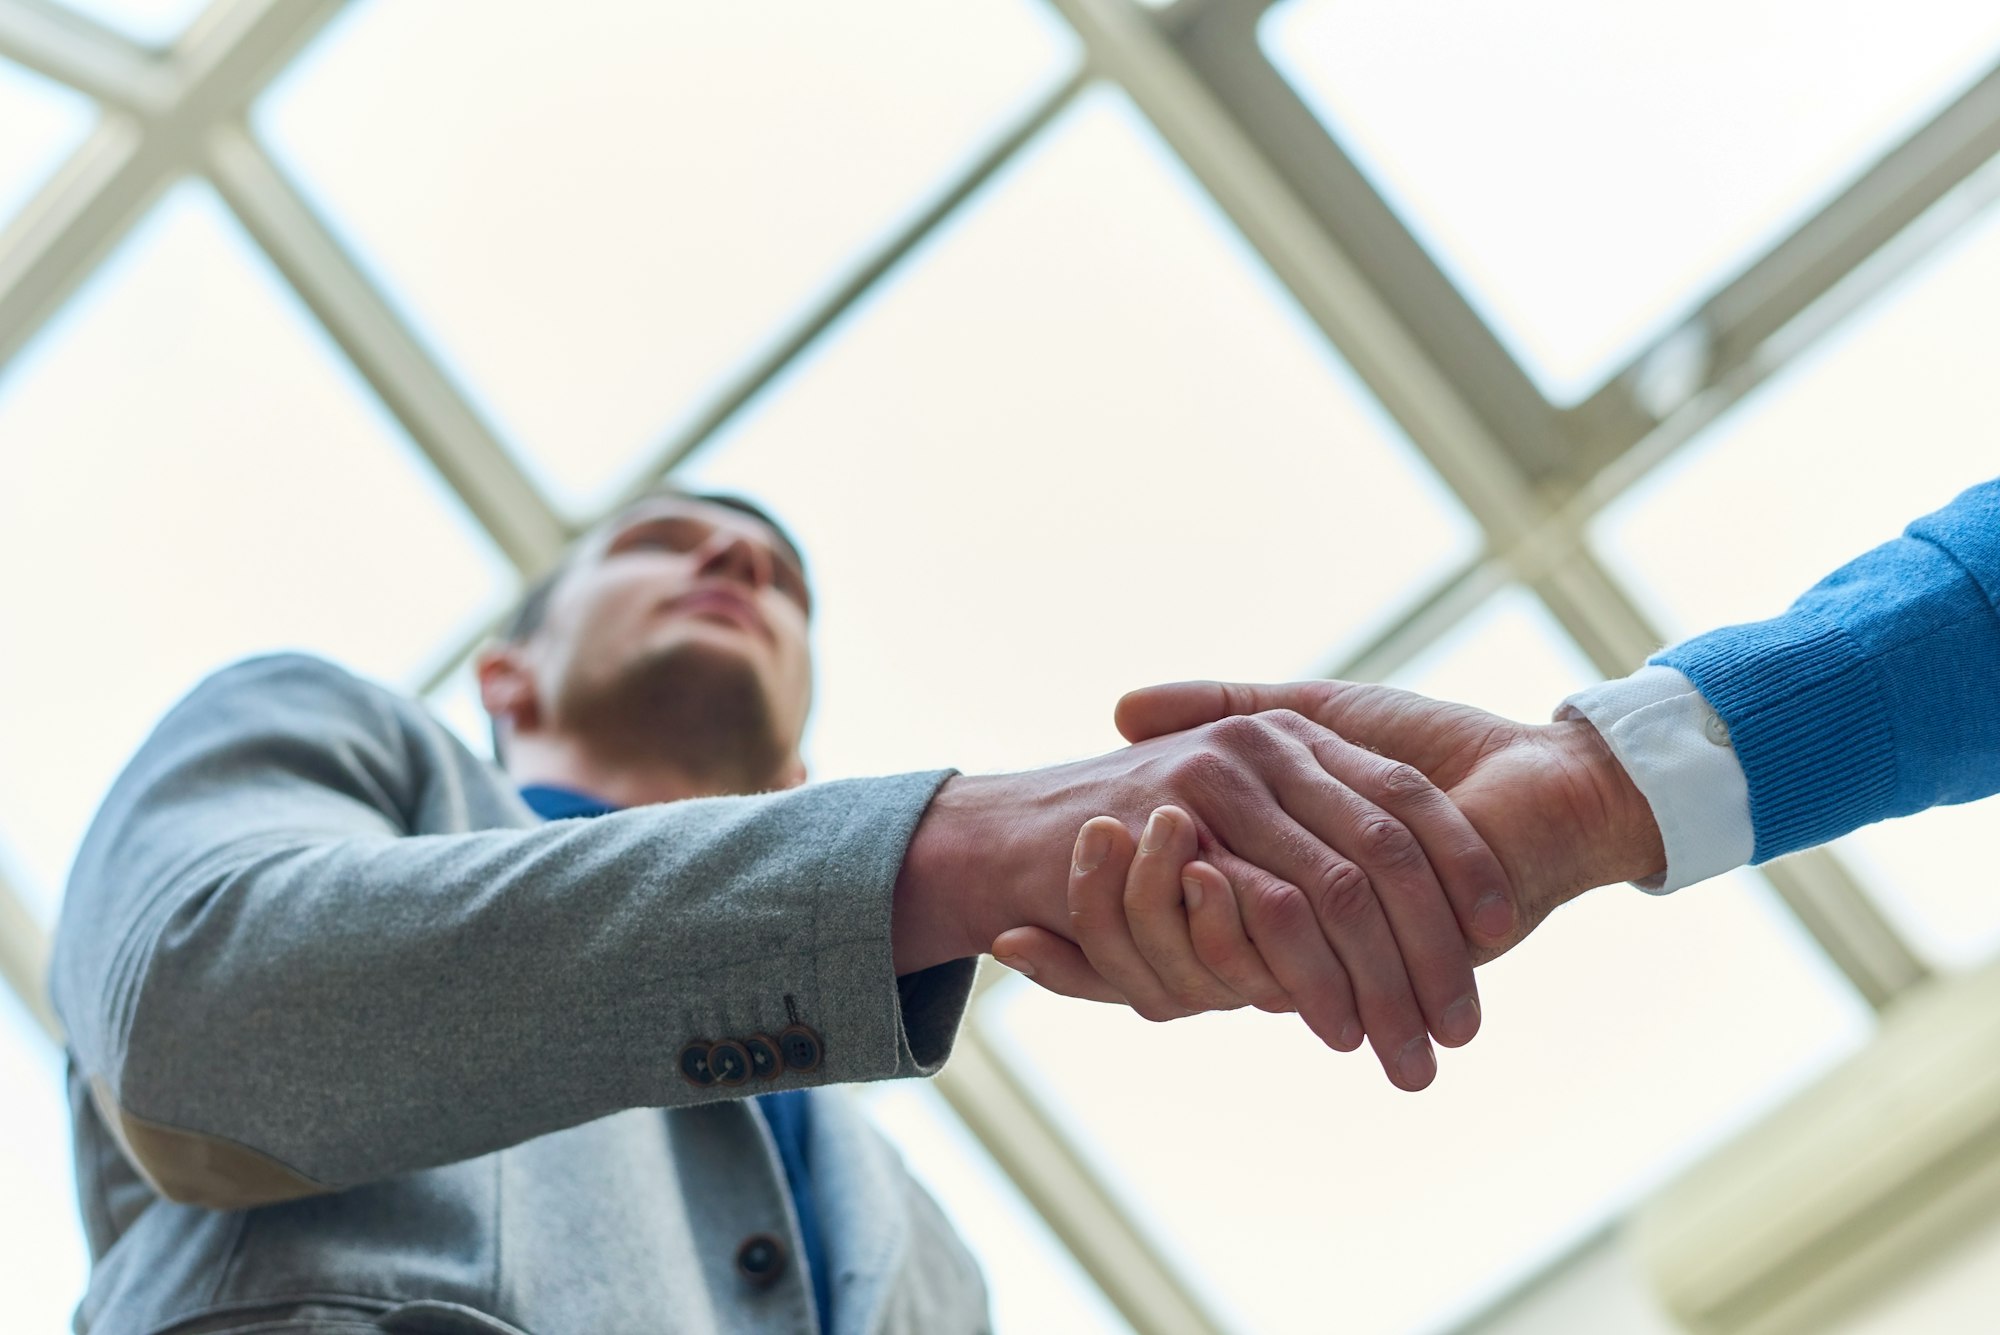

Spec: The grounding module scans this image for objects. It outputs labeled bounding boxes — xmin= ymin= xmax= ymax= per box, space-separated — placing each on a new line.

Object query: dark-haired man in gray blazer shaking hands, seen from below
xmin=54 ymin=492 xmax=1512 ymax=1335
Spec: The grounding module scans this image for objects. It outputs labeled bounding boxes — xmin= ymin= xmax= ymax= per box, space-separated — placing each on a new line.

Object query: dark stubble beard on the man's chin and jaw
xmin=560 ymin=644 xmax=792 ymax=793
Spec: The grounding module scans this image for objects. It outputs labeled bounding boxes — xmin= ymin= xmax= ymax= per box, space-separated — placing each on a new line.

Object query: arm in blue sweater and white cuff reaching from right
xmin=1008 ymin=473 xmax=2000 ymax=1007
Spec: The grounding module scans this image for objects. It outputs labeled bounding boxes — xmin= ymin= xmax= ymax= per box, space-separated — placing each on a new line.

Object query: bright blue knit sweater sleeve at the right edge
xmin=1652 ymin=480 xmax=2000 ymax=861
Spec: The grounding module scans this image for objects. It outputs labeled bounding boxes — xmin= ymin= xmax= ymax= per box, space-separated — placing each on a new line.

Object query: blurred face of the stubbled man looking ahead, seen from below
xmin=484 ymin=496 xmax=812 ymax=791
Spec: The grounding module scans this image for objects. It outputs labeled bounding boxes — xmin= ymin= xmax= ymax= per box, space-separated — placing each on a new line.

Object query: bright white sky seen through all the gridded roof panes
xmin=0 ymin=0 xmax=2000 ymax=1333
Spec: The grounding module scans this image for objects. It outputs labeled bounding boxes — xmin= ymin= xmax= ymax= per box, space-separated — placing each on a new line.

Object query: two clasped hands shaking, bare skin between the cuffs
xmin=894 ymin=681 xmax=1666 ymax=1089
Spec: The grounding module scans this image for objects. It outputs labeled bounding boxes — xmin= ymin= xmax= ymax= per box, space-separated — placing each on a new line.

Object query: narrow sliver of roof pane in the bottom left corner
xmin=0 ymin=987 xmax=88 ymax=1331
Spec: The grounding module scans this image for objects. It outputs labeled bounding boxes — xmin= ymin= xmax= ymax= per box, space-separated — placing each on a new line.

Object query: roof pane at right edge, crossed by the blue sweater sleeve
xmin=1592 ymin=176 xmax=2000 ymax=965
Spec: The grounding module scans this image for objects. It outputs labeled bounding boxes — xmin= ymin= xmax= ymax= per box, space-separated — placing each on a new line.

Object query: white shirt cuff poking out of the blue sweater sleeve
xmin=1556 ymin=664 xmax=1756 ymax=895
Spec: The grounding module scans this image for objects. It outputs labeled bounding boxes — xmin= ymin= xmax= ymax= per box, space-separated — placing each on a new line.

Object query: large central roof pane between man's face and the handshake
xmin=690 ymin=92 xmax=1476 ymax=775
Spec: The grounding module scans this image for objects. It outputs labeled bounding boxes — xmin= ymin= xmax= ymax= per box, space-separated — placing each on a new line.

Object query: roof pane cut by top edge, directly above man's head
xmin=260 ymin=0 xmax=1074 ymax=512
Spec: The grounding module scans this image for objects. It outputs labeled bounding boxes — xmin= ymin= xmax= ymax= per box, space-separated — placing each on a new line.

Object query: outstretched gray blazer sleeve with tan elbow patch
xmin=52 ymin=656 xmax=974 ymax=1207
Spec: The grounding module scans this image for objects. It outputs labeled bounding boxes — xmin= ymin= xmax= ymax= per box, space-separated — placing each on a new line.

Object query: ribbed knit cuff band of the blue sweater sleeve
xmin=1652 ymin=612 xmax=1896 ymax=861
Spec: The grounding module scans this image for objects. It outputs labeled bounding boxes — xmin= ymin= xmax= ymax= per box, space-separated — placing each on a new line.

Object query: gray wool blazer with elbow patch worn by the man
xmin=52 ymin=656 xmax=988 ymax=1335
